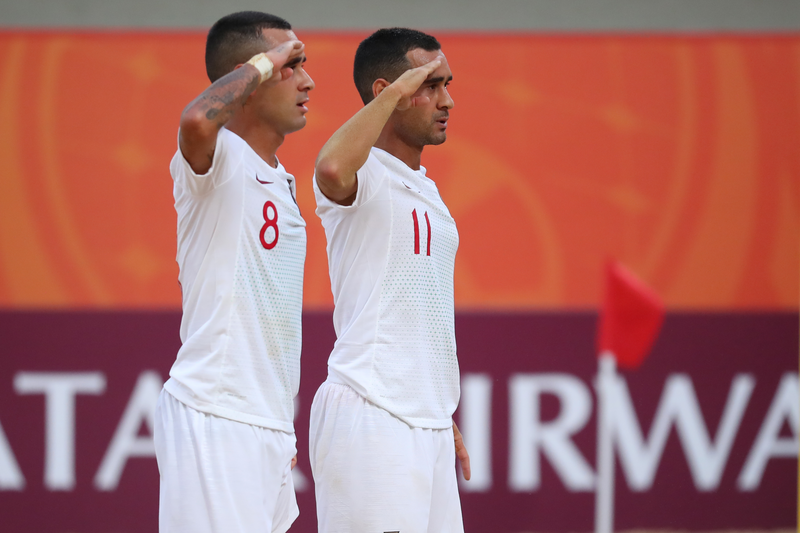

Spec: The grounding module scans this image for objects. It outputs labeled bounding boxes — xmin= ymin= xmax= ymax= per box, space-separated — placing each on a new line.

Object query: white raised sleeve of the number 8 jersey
xmin=169 ymin=128 xmax=242 ymax=196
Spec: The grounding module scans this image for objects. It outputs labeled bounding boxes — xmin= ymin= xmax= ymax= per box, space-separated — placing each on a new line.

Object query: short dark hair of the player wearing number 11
xmin=353 ymin=28 xmax=442 ymax=104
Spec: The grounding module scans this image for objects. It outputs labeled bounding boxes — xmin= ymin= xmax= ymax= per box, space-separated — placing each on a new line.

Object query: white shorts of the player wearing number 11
xmin=309 ymin=381 xmax=464 ymax=533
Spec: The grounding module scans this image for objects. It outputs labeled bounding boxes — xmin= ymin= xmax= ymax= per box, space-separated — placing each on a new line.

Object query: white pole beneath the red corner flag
xmin=594 ymin=351 xmax=617 ymax=533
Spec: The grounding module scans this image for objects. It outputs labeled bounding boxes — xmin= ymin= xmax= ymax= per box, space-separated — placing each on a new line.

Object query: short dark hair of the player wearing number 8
xmin=206 ymin=11 xmax=292 ymax=83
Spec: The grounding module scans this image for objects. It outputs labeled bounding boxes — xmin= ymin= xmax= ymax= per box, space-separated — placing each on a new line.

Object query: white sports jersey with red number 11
xmin=314 ymin=148 xmax=459 ymax=428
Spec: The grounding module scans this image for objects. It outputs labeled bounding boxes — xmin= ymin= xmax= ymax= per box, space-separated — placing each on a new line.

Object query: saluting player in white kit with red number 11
xmin=310 ymin=28 xmax=469 ymax=533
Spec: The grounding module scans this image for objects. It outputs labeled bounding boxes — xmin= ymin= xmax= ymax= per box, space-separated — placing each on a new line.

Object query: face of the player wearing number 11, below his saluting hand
xmin=395 ymin=48 xmax=454 ymax=149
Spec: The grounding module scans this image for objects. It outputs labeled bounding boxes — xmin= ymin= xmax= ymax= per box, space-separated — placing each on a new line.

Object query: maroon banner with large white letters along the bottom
xmin=0 ymin=312 xmax=800 ymax=533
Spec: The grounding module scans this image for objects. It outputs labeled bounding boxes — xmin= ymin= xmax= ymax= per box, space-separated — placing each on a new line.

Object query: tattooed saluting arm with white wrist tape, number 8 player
xmin=178 ymin=41 xmax=304 ymax=174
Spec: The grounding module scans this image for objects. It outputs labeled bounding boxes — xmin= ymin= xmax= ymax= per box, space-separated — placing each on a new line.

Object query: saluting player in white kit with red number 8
xmin=154 ymin=12 xmax=314 ymax=533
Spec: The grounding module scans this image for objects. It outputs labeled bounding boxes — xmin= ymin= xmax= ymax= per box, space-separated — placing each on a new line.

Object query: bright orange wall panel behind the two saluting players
xmin=0 ymin=31 xmax=800 ymax=310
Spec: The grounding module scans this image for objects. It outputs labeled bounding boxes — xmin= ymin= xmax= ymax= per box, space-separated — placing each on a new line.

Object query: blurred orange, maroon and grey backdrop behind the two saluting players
xmin=0 ymin=0 xmax=800 ymax=533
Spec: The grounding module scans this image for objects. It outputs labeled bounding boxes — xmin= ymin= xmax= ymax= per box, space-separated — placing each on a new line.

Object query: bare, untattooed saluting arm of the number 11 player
xmin=315 ymin=59 xmax=441 ymax=205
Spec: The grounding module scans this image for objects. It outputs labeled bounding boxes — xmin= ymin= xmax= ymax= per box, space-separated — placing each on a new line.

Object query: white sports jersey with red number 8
xmin=164 ymin=128 xmax=306 ymax=432
